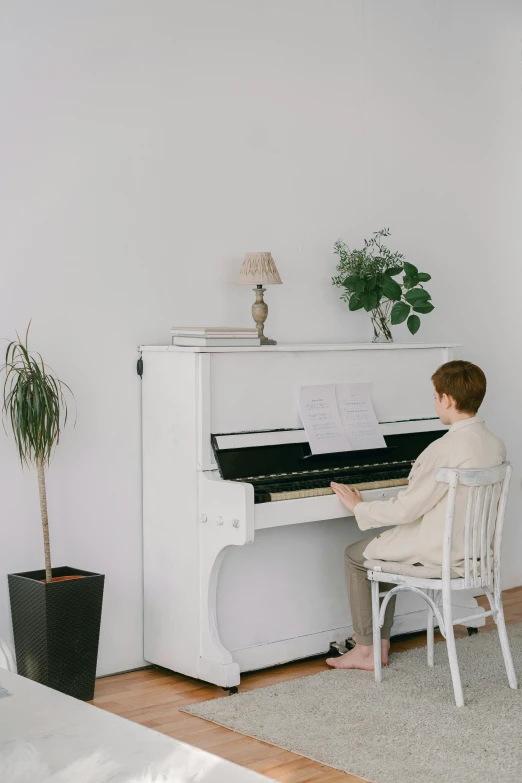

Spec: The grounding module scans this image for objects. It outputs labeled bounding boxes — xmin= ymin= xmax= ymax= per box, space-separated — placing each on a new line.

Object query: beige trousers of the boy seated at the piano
xmin=344 ymin=538 xmax=396 ymax=644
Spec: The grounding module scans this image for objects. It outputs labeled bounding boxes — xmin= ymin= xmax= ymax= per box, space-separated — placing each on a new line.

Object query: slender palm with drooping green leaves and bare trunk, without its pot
xmin=0 ymin=323 xmax=72 ymax=582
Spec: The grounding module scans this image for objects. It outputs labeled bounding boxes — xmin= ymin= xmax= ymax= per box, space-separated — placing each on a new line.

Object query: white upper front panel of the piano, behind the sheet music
xmin=210 ymin=345 xmax=447 ymax=433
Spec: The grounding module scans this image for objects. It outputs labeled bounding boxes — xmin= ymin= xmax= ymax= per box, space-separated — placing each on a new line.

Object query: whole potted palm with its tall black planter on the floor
xmin=1 ymin=324 xmax=104 ymax=700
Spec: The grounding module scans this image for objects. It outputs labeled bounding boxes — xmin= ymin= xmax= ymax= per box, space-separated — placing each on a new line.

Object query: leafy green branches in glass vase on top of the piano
xmin=332 ymin=228 xmax=434 ymax=340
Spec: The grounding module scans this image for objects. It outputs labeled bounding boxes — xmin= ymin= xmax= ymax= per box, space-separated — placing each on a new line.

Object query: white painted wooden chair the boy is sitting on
xmin=365 ymin=462 xmax=518 ymax=707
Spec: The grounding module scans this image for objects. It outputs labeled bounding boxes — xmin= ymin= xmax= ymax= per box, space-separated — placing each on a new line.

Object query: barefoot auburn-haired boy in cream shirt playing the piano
xmin=326 ymin=361 xmax=506 ymax=670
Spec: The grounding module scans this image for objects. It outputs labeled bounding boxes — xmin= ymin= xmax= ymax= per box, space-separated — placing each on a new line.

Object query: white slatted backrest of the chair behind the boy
xmin=436 ymin=462 xmax=512 ymax=589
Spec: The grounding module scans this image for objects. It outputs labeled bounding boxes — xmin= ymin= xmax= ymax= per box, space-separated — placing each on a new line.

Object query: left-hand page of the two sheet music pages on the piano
xmin=299 ymin=384 xmax=351 ymax=454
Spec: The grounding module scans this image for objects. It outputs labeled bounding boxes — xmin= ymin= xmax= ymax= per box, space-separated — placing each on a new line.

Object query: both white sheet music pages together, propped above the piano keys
xmin=299 ymin=383 xmax=386 ymax=454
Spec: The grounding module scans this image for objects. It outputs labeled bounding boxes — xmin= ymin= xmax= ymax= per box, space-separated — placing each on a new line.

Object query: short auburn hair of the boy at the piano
xmin=431 ymin=359 xmax=486 ymax=413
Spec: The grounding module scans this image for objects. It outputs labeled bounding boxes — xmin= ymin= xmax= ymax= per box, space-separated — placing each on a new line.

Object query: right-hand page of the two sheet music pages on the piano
xmin=335 ymin=383 xmax=386 ymax=449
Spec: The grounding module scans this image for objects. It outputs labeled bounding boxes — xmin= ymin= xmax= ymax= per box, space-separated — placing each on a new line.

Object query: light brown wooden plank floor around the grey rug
xmin=91 ymin=587 xmax=522 ymax=783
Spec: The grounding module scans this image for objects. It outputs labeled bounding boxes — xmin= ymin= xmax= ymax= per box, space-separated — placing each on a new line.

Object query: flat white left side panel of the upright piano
xmin=141 ymin=352 xmax=199 ymax=677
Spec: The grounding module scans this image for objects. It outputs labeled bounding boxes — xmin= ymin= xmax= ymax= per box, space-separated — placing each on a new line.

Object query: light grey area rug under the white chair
xmin=184 ymin=623 xmax=522 ymax=783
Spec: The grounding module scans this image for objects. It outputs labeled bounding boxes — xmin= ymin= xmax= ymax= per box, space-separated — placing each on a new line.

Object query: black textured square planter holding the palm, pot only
xmin=7 ymin=567 xmax=105 ymax=700
